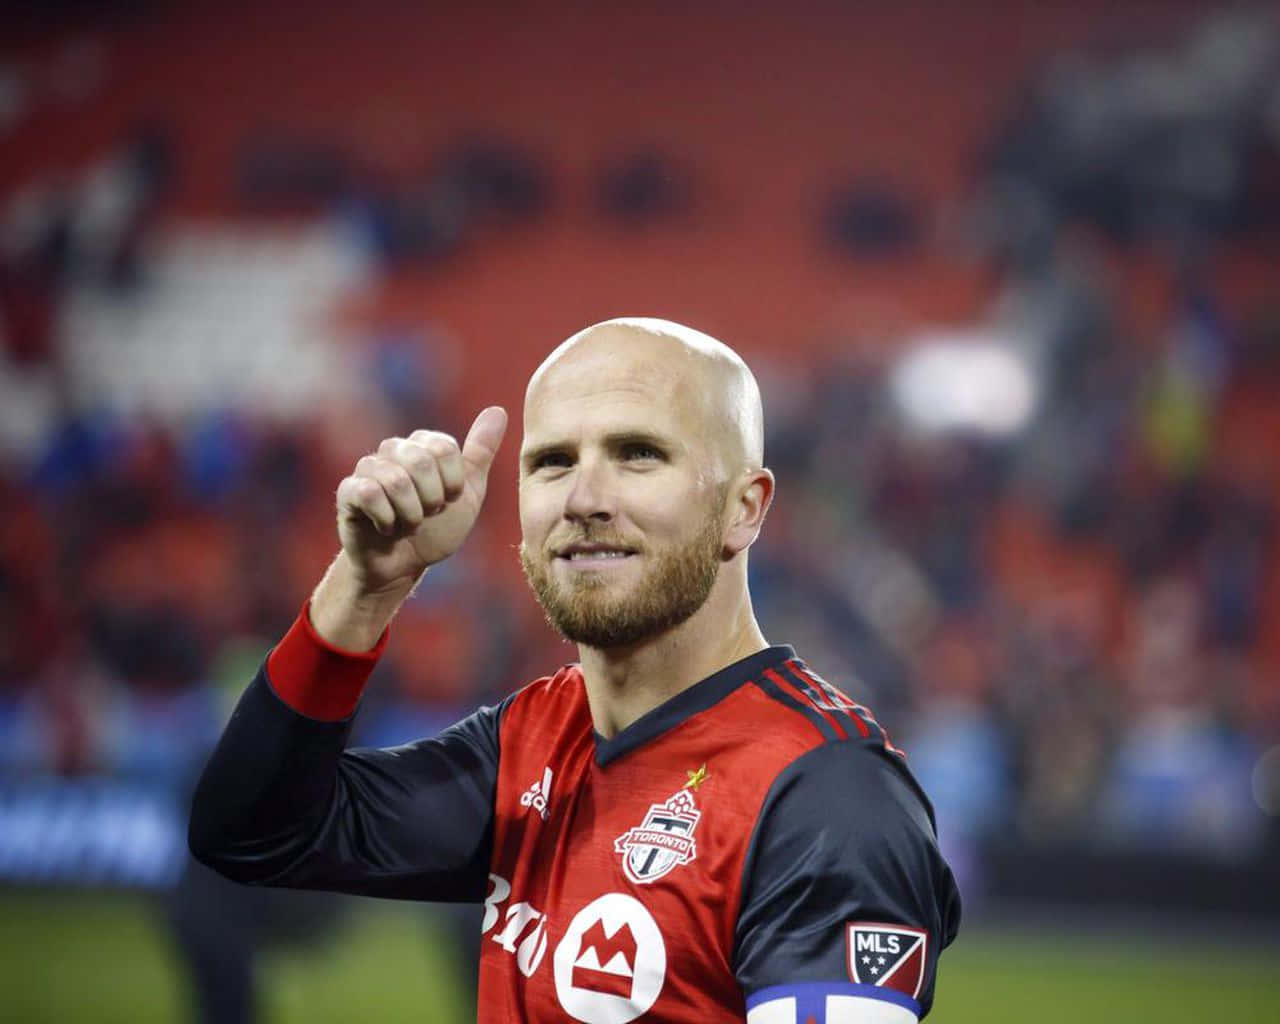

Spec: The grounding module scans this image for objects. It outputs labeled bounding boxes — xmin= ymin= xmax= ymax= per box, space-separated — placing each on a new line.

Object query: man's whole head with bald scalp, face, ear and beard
xmin=520 ymin=317 xmax=773 ymax=649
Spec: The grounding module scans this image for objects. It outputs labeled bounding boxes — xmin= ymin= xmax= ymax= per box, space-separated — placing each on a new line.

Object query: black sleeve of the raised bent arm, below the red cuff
xmin=188 ymin=668 xmax=506 ymax=902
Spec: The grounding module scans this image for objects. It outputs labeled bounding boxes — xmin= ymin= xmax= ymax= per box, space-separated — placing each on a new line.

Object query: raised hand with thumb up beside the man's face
xmin=338 ymin=406 xmax=507 ymax=590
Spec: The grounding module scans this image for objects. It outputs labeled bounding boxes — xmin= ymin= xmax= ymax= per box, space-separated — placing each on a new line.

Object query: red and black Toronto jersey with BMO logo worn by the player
xmin=191 ymin=616 xmax=960 ymax=1024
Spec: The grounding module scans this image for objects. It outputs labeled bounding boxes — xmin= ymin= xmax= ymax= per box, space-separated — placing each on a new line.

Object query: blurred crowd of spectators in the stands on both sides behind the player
xmin=0 ymin=6 xmax=1280 ymax=896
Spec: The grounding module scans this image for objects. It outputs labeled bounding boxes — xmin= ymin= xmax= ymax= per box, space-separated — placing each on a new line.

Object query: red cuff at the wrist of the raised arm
xmin=266 ymin=600 xmax=388 ymax=722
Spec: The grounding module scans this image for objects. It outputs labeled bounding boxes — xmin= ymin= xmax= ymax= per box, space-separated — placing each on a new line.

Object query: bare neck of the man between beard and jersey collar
xmin=579 ymin=580 xmax=768 ymax=739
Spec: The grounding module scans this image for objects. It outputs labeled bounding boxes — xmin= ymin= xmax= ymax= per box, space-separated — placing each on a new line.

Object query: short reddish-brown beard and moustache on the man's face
xmin=520 ymin=503 xmax=723 ymax=648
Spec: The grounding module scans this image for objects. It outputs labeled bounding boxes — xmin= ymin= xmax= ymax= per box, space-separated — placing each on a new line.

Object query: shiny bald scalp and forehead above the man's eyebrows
xmin=525 ymin=317 xmax=764 ymax=476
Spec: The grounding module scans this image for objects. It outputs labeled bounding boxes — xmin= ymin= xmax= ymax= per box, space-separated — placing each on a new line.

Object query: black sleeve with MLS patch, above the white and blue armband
xmin=735 ymin=740 xmax=960 ymax=1020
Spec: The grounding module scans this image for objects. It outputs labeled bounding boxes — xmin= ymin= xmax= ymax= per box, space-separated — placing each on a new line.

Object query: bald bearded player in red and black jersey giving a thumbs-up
xmin=191 ymin=320 xmax=959 ymax=1024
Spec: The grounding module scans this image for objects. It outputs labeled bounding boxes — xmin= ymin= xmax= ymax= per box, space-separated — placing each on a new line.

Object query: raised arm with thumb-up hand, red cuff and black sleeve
xmin=188 ymin=410 xmax=506 ymax=900
